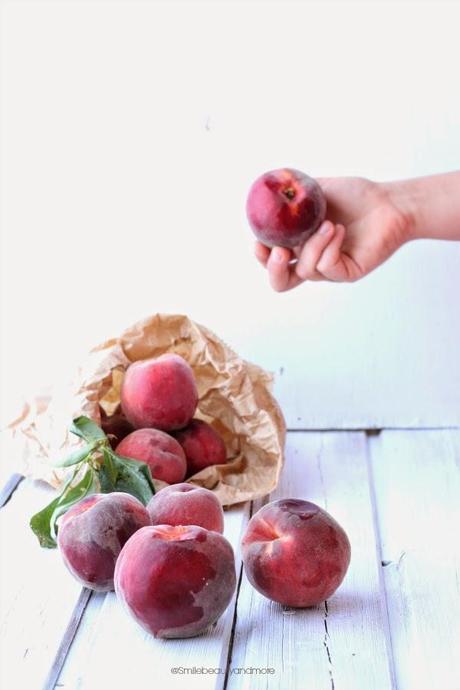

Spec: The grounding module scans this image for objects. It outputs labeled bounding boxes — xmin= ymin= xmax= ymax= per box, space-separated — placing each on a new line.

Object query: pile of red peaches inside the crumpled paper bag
xmin=102 ymin=354 xmax=227 ymax=484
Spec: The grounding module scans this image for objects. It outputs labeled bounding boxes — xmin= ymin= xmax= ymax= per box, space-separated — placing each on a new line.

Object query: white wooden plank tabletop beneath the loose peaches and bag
xmin=0 ymin=429 xmax=460 ymax=690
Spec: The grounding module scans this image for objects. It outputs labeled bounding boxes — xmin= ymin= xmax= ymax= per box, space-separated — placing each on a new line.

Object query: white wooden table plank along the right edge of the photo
xmin=371 ymin=430 xmax=460 ymax=690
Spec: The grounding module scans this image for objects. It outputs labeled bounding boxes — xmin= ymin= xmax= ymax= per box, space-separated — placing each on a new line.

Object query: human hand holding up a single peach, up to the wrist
xmin=255 ymin=177 xmax=409 ymax=292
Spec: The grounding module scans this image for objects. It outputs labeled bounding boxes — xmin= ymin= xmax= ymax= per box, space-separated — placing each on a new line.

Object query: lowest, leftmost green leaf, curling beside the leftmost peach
xmin=30 ymin=467 xmax=99 ymax=549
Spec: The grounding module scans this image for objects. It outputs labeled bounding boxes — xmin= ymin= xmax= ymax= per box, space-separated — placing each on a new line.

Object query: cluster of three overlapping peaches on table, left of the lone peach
xmin=58 ymin=483 xmax=236 ymax=637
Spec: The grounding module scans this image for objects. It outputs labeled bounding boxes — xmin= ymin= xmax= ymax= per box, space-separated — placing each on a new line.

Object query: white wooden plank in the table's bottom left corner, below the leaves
xmin=0 ymin=479 xmax=81 ymax=690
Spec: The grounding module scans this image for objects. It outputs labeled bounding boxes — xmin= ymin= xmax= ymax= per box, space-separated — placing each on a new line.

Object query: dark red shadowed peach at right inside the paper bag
xmin=174 ymin=419 xmax=227 ymax=476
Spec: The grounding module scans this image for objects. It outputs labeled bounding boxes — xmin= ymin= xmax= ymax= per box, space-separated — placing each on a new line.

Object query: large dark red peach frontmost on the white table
xmin=115 ymin=525 xmax=236 ymax=638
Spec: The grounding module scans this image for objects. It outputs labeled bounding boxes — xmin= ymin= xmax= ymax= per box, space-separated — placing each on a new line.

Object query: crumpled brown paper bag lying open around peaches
xmin=10 ymin=314 xmax=286 ymax=505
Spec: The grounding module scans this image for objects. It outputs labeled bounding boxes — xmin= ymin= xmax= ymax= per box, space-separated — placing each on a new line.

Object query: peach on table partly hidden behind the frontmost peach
xmin=147 ymin=482 xmax=224 ymax=533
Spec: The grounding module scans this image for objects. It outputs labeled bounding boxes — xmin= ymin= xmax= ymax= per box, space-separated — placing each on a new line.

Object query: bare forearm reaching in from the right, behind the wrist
xmin=384 ymin=171 xmax=460 ymax=240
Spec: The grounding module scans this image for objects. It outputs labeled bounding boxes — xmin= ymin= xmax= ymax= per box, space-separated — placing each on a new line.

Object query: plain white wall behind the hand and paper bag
xmin=1 ymin=0 xmax=460 ymax=428
